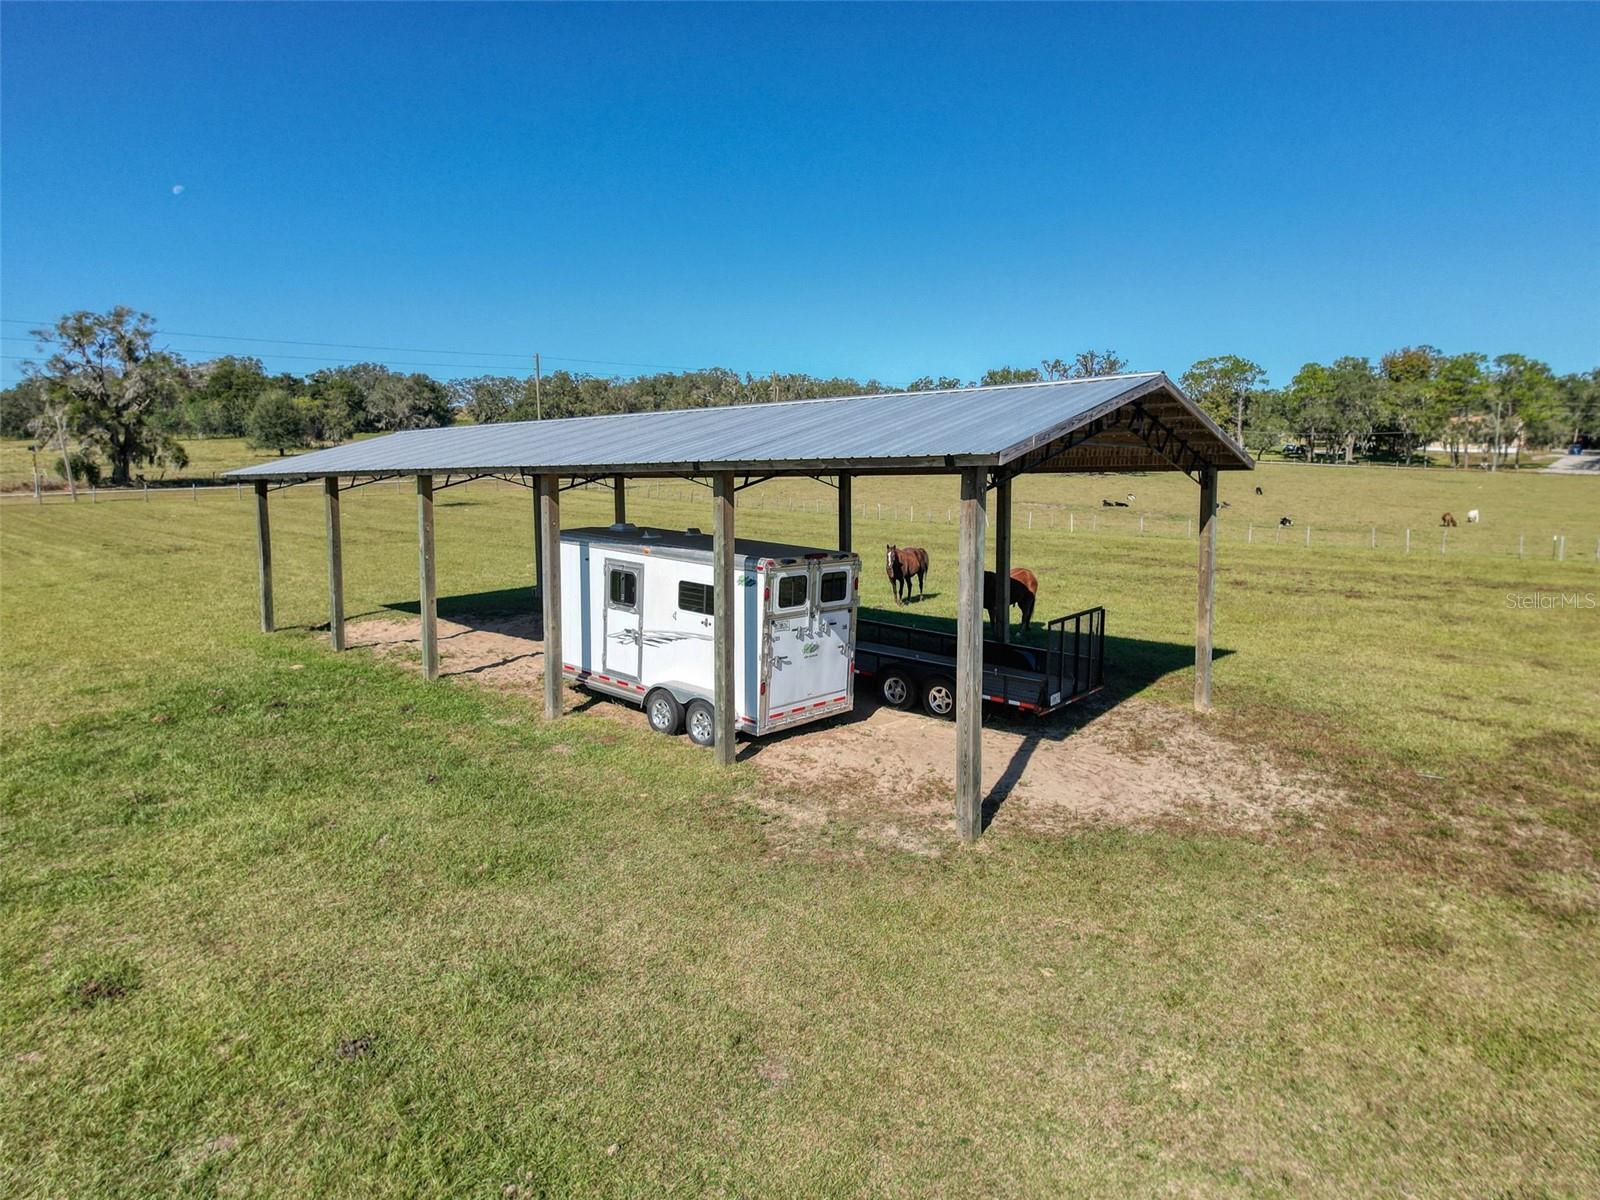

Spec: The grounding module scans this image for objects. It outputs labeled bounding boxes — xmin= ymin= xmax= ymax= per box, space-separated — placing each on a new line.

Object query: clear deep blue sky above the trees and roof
xmin=0 ymin=3 xmax=1600 ymax=384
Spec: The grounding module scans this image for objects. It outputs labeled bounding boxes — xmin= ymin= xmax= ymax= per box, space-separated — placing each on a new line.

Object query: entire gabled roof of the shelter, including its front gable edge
xmin=227 ymin=373 xmax=1253 ymax=480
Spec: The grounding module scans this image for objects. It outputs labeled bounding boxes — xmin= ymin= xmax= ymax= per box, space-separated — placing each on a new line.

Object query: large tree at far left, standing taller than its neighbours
xmin=32 ymin=306 xmax=182 ymax=486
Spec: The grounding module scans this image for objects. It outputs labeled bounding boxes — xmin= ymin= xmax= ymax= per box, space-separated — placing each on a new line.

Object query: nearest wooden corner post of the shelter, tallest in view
xmin=955 ymin=467 xmax=989 ymax=842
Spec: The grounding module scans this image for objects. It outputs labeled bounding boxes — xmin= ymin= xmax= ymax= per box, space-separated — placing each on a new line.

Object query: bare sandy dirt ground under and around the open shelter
xmin=340 ymin=614 xmax=1334 ymax=853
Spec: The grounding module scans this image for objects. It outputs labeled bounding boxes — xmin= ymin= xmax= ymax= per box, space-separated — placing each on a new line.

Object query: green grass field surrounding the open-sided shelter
xmin=0 ymin=467 xmax=1600 ymax=1197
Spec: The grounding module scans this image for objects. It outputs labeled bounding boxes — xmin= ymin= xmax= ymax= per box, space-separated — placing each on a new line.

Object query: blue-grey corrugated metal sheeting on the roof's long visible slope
xmin=229 ymin=373 xmax=1248 ymax=478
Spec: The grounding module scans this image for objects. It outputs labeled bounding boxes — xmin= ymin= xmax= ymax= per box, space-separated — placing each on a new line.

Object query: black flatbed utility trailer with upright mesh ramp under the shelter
xmin=856 ymin=608 xmax=1106 ymax=717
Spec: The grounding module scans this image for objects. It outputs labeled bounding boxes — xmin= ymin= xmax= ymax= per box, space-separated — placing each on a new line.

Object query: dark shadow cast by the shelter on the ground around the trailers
xmin=371 ymin=587 xmax=1232 ymax=827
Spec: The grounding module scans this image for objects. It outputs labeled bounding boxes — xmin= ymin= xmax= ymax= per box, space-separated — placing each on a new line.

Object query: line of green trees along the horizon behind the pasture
xmin=0 ymin=307 xmax=1600 ymax=485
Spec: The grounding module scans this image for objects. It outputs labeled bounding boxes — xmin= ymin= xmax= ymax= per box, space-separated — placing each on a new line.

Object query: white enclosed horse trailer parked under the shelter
xmin=562 ymin=525 xmax=861 ymax=746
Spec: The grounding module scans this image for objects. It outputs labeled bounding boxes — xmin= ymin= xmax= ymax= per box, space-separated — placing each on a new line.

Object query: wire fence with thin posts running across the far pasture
xmin=0 ymin=475 xmax=1600 ymax=563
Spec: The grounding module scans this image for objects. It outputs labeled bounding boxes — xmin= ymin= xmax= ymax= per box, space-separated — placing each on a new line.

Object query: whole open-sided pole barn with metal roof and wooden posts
xmin=227 ymin=373 xmax=1254 ymax=840
